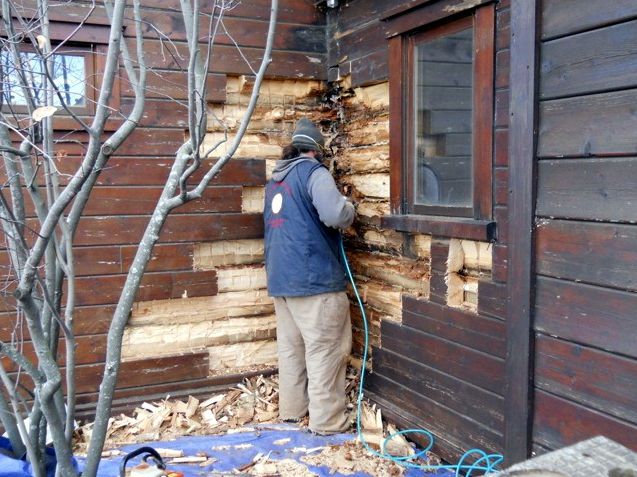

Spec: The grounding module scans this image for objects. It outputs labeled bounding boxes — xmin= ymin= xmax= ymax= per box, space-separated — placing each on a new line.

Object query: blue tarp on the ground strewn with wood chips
xmin=80 ymin=425 xmax=454 ymax=477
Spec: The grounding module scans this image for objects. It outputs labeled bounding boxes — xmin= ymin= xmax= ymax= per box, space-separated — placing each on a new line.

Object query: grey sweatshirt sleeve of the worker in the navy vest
xmin=307 ymin=167 xmax=356 ymax=229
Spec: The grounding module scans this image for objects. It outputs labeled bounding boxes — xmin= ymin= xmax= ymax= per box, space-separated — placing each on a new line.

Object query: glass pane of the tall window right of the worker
xmin=412 ymin=27 xmax=473 ymax=207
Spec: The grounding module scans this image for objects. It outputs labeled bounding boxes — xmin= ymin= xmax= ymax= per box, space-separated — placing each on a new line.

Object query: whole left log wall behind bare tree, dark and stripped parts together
xmin=0 ymin=0 xmax=326 ymax=414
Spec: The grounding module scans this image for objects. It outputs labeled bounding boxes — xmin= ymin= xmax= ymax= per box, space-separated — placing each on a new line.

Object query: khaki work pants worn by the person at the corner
xmin=274 ymin=292 xmax=352 ymax=433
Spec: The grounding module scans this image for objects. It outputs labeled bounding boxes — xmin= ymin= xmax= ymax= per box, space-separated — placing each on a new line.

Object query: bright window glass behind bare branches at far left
xmin=0 ymin=50 xmax=86 ymax=107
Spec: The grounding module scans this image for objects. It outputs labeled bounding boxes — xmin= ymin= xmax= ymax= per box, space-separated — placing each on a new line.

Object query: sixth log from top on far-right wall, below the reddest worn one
xmin=534 ymin=277 xmax=637 ymax=358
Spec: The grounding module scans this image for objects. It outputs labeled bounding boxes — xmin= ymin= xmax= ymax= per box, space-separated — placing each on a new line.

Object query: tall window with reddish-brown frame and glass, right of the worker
xmin=389 ymin=5 xmax=494 ymax=220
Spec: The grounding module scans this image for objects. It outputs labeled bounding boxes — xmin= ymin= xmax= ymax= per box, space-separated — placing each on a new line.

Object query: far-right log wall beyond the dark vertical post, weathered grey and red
xmin=533 ymin=0 xmax=637 ymax=452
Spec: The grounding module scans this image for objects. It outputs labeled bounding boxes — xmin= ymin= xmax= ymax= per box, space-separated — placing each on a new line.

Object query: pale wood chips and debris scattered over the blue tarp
xmin=75 ymin=369 xmax=437 ymax=477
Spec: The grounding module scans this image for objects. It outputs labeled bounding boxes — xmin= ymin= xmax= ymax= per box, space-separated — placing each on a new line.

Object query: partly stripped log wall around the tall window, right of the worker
xmin=328 ymin=0 xmax=510 ymax=460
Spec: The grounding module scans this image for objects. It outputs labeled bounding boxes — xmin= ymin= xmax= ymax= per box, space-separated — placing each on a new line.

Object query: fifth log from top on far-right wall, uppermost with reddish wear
xmin=536 ymin=220 xmax=637 ymax=290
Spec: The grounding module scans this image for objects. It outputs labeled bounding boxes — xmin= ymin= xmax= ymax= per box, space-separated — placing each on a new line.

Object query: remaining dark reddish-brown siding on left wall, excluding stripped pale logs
xmin=0 ymin=0 xmax=327 ymax=415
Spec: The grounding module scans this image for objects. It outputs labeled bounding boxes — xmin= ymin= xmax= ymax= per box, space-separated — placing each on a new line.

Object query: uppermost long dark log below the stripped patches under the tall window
xmin=403 ymin=296 xmax=506 ymax=358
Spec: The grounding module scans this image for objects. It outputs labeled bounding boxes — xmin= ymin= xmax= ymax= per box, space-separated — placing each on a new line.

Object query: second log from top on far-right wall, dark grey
xmin=540 ymin=18 xmax=637 ymax=99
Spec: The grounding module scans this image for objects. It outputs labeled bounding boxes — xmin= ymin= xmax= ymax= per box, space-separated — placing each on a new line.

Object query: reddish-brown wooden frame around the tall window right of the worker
xmin=386 ymin=2 xmax=495 ymax=231
